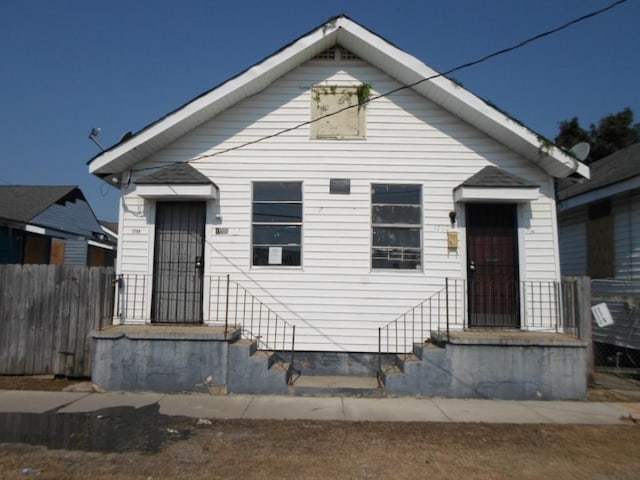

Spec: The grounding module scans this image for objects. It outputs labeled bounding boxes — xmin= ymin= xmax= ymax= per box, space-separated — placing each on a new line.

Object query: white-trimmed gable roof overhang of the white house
xmin=89 ymin=16 xmax=589 ymax=182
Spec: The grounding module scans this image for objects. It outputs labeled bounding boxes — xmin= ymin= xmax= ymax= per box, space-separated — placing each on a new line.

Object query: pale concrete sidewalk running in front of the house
xmin=0 ymin=390 xmax=640 ymax=425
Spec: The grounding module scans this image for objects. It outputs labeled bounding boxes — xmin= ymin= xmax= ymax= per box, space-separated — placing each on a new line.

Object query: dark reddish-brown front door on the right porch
xmin=466 ymin=203 xmax=520 ymax=328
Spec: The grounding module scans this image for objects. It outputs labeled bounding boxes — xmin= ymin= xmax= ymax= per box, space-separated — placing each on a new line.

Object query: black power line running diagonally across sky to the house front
xmin=134 ymin=0 xmax=629 ymax=172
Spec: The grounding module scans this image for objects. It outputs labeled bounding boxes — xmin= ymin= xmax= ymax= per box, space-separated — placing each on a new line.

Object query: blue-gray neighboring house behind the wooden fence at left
xmin=0 ymin=185 xmax=116 ymax=266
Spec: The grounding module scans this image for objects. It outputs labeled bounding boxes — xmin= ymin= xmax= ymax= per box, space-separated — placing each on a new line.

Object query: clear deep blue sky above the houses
xmin=0 ymin=0 xmax=640 ymax=220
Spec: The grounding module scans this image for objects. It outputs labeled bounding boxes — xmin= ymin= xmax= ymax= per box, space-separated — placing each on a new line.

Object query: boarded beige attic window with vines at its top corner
xmin=311 ymin=85 xmax=366 ymax=140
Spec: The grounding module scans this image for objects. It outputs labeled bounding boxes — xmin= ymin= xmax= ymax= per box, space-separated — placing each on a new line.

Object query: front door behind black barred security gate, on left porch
xmin=151 ymin=202 xmax=206 ymax=323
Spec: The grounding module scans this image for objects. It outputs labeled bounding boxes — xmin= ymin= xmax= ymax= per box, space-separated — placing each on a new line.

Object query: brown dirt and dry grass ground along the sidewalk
xmin=0 ymin=377 xmax=640 ymax=480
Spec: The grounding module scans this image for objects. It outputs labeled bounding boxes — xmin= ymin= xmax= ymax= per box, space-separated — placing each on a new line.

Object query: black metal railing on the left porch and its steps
xmin=116 ymin=274 xmax=299 ymax=383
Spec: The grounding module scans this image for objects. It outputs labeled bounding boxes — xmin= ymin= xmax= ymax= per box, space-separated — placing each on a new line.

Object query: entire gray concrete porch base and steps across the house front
xmin=92 ymin=326 xmax=587 ymax=400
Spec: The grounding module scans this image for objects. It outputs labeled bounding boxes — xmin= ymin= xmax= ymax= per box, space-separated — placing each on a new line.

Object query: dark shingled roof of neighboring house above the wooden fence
xmin=0 ymin=185 xmax=79 ymax=223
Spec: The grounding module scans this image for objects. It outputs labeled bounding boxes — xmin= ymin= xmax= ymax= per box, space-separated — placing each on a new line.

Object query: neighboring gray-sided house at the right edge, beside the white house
xmin=558 ymin=143 xmax=640 ymax=354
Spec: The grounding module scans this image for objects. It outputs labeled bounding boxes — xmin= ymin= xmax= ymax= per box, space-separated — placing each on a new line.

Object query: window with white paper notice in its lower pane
xmin=252 ymin=182 xmax=302 ymax=266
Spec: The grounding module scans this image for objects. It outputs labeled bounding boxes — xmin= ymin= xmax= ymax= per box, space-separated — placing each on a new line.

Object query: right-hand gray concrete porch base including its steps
xmin=384 ymin=340 xmax=587 ymax=400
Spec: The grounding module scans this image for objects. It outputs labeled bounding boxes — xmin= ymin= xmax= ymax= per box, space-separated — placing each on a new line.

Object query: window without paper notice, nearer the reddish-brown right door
xmin=371 ymin=183 xmax=422 ymax=270
